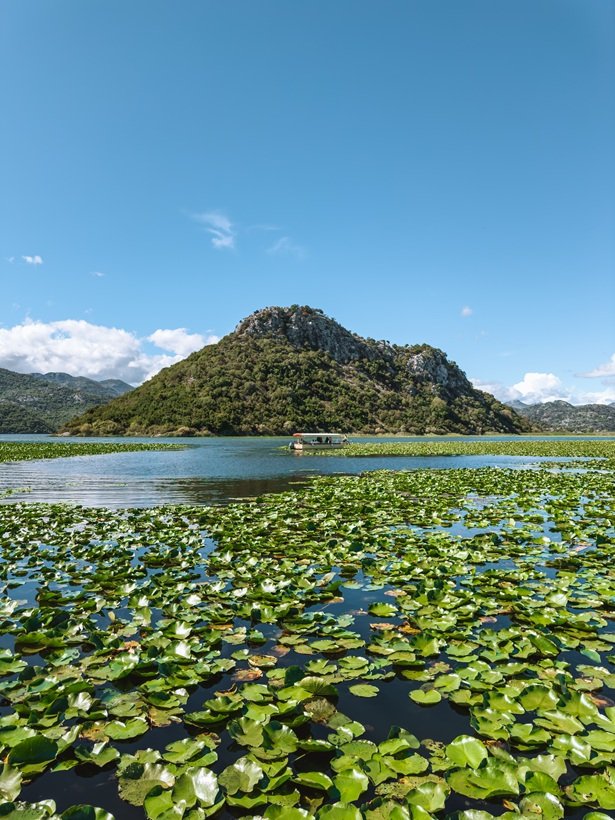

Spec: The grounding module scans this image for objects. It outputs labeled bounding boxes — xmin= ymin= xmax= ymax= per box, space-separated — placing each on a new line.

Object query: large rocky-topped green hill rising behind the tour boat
xmin=66 ymin=305 xmax=531 ymax=435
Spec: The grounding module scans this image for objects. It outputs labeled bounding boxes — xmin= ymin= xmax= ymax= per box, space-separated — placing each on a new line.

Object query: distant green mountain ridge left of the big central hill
xmin=0 ymin=368 xmax=133 ymax=433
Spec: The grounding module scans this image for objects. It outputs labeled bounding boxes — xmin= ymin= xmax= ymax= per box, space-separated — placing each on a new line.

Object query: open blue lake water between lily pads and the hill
xmin=0 ymin=435 xmax=592 ymax=507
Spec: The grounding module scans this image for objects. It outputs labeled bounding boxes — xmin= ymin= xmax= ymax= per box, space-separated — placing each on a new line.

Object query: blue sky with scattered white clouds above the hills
xmin=0 ymin=0 xmax=615 ymax=401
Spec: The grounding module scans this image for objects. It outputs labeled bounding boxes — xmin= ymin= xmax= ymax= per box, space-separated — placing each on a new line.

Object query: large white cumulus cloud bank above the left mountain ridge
xmin=0 ymin=319 xmax=218 ymax=384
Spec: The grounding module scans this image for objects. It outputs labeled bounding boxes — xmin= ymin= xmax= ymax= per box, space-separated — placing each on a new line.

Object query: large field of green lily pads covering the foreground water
xmin=0 ymin=440 xmax=615 ymax=820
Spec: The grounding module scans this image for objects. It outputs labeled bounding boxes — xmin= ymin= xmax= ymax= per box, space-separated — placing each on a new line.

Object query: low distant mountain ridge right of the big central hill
xmin=509 ymin=400 xmax=615 ymax=433
